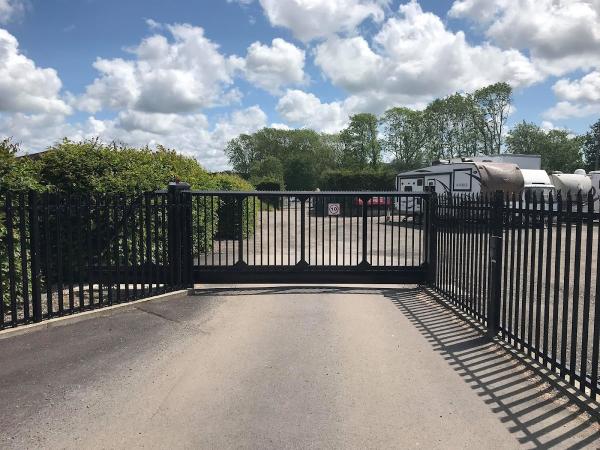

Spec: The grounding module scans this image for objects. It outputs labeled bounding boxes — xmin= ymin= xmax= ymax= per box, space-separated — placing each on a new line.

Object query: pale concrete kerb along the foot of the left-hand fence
xmin=0 ymin=289 xmax=190 ymax=341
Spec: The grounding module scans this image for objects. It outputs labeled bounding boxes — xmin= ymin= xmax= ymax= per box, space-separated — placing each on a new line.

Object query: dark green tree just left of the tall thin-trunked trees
xmin=340 ymin=113 xmax=381 ymax=167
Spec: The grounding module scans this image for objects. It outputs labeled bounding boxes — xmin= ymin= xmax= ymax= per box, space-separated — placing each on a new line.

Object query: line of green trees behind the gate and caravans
xmin=225 ymin=83 xmax=600 ymax=190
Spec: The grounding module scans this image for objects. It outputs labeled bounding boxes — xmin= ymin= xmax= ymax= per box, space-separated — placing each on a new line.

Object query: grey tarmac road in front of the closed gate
xmin=0 ymin=287 xmax=600 ymax=449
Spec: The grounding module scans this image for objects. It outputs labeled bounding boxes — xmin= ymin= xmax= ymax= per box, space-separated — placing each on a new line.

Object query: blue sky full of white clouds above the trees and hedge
xmin=0 ymin=0 xmax=600 ymax=170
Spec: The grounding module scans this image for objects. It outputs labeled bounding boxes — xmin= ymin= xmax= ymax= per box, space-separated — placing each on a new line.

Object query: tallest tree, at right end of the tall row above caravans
xmin=473 ymin=83 xmax=512 ymax=155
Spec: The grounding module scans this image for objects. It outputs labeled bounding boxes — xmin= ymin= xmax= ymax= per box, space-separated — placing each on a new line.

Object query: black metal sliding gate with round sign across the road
xmin=180 ymin=191 xmax=431 ymax=283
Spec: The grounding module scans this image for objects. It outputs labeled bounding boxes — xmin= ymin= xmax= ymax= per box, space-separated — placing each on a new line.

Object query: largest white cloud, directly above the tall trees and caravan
xmin=315 ymin=1 xmax=542 ymax=113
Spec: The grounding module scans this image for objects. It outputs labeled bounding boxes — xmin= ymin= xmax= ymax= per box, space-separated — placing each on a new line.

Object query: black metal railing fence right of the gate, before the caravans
xmin=432 ymin=193 xmax=600 ymax=398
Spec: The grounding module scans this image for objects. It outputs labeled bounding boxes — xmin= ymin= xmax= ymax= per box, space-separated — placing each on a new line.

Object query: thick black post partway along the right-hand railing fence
xmin=487 ymin=191 xmax=504 ymax=336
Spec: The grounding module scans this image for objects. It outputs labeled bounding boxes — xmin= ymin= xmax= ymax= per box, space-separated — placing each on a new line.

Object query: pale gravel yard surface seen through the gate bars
xmin=198 ymin=203 xmax=425 ymax=267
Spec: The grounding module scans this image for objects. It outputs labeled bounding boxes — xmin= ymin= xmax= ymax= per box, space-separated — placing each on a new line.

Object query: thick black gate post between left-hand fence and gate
xmin=167 ymin=182 xmax=193 ymax=286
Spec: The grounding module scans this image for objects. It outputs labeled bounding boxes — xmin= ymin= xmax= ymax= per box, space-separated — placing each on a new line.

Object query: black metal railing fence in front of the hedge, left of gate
xmin=0 ymin=188 xmax=182 ymax=329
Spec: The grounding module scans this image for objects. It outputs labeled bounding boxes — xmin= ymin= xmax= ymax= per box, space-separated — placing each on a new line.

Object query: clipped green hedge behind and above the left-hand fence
xmin=0 ymin=139 xmax=254 ymax=310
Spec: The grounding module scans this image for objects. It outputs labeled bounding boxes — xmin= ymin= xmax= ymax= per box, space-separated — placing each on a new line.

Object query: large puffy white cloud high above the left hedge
xmin=77 ymin=25 xmax=243 ymax=114
